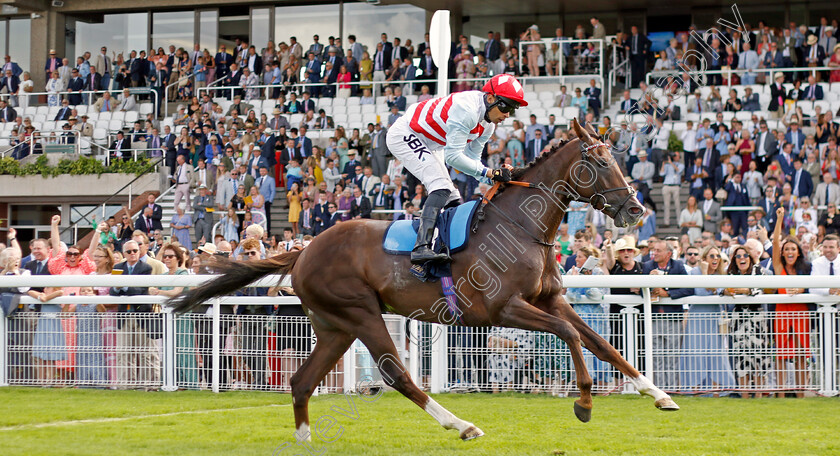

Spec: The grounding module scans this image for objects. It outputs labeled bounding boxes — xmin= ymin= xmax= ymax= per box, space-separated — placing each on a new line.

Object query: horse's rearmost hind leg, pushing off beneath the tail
xmin=290 ymin=325 xmax=355 ymax=441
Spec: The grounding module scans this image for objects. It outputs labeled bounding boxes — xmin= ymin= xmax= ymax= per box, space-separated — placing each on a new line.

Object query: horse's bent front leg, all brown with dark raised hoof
xmin=494 ymin=296 xmax=592 ymax=423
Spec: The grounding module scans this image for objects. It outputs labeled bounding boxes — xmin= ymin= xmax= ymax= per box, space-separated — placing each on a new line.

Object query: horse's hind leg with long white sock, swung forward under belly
xmin=359 ymin=315 xmax=484 ymax=440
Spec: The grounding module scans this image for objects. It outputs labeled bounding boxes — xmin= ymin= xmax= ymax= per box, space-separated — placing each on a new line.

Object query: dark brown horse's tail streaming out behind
xmin=169 ymin=250 xmax=302 ymax=312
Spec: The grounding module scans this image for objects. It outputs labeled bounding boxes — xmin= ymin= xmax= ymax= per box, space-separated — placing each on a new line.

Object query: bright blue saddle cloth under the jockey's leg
xmin=382 ymin=200 xmax=478 ymax=255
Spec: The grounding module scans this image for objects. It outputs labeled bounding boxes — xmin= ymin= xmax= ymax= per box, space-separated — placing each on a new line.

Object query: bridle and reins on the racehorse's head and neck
xmin=480 ymin=141 xmax=636 ymax=247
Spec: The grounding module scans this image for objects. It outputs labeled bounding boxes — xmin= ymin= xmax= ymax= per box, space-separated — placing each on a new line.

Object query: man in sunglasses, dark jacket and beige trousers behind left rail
xmin=109 ymin=240 xmax=155 ymax=385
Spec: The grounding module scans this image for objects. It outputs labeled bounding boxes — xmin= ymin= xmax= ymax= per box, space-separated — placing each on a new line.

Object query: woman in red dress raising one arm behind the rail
xmin=773 ymin=207 xmax=811 ymax=397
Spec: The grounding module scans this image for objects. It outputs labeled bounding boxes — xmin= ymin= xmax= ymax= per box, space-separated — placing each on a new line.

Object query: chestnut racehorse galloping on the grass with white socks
xmin=173 ymin=120 xmax=679 ymax=440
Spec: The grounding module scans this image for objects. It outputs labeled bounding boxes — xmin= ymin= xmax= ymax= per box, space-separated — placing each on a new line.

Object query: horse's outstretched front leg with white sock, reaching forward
xmin=540 ymin=293 xmax=680 ymax=411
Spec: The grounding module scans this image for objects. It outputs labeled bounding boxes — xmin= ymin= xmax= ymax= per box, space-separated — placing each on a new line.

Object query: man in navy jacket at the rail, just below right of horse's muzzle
xmin=642 ymin=239 xmax=694 ymax=385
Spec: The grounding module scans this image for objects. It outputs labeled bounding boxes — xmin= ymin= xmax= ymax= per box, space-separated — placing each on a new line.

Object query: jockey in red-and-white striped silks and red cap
xmin=387 ymin=74 xmax=528 ymax=264
